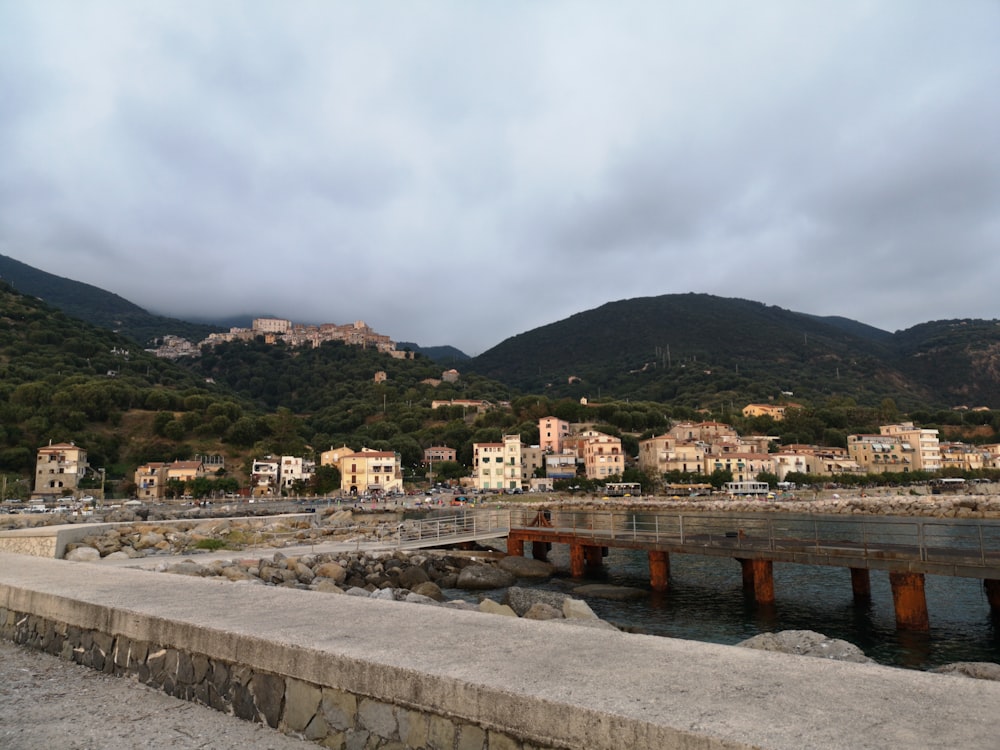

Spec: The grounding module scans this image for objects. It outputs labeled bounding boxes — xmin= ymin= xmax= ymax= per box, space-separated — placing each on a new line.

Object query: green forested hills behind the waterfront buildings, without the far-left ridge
xmin=0 ymin=264 xmax=1000 ymax=500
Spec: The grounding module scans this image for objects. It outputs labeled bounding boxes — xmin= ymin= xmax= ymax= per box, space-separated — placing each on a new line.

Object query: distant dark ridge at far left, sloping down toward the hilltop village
xmin=0 ymin=255 xmax=218 ymax=346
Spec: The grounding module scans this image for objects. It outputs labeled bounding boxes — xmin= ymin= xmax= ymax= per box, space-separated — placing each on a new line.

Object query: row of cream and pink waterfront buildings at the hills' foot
xmin=32 ymin=412 xmax=1000 ymax=502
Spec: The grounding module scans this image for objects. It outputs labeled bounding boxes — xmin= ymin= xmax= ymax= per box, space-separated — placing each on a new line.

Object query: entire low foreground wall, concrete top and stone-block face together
xmin=0 ymin=554 xmax=1000 ymax=750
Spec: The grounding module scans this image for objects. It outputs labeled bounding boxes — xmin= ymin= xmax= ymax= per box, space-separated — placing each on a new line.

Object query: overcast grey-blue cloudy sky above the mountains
xmin=0 ymin=0 xmax=1000 ymax=355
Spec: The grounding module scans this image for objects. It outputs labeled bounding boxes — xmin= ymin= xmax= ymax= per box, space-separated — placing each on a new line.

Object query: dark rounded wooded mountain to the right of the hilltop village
xmin=464 ymin=294 xmax=1000 ymax=408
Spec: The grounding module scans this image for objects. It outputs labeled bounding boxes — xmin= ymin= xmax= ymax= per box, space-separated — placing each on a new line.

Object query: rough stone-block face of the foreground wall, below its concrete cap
xmin=0 ymin=607 xmax=566 ymax=750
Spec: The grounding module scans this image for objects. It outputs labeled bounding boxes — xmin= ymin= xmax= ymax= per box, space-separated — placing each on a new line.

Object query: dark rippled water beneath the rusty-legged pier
xmin=458 ymin=545 xmax=1000 ymax=670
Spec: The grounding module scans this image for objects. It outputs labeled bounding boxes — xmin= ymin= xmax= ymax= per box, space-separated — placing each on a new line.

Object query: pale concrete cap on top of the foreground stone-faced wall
xmin=0 ymin=555 xmax=1000 ymax=750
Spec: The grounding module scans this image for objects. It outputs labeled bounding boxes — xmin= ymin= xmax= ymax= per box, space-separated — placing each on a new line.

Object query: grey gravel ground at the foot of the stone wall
xmin=0 ymin=640 xmax=318 ymax=750
